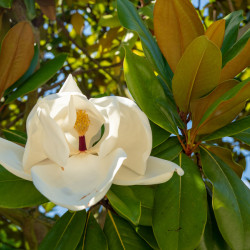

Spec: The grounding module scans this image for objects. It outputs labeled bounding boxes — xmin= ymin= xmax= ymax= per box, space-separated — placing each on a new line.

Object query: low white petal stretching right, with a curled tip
xmin=113 ymin=156 xmax=184 ymax=185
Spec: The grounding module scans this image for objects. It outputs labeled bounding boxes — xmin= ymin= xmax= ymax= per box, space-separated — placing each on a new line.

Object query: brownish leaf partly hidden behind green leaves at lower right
xmin=206 ymin=146 xmax=244 ymax=178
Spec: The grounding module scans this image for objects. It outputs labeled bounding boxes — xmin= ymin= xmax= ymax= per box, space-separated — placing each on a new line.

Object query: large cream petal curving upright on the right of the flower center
xmin=90 ymin=96 xmax=152 ymax=175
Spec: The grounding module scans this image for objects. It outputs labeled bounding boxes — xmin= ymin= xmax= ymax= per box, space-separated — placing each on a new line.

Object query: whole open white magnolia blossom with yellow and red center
xmin=0 ymin=75 xmax=183 ymax=210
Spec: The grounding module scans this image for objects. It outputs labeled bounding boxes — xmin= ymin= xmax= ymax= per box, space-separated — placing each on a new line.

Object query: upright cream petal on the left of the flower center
xmin=23 ymin=102 xmax=69 ymax=171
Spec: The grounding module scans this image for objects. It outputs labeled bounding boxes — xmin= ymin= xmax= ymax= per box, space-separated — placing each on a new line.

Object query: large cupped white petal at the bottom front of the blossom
xmin=31 ymin=149 xmax=126 ymax=210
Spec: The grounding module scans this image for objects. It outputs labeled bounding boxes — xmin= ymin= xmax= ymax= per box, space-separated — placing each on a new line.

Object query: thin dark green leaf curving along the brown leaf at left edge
xmin=4 ymin=45 xmax=39 ymax=96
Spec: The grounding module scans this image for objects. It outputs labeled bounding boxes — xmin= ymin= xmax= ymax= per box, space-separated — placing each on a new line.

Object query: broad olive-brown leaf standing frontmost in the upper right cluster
xmin=172 ymin=36 xmax=222 ymax=113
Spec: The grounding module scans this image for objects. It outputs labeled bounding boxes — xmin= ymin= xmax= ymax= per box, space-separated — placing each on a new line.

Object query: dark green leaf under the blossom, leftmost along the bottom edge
xmin=39 ymin=210 xmax=86 ymax=250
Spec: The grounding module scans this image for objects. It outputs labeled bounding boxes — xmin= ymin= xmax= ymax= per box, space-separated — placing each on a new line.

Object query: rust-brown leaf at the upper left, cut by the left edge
xmin=0 ymin=22 xmax=34 ymax=96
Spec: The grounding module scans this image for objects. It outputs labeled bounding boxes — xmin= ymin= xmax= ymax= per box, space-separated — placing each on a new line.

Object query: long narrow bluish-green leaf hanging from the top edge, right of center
xmin=117 ymin=0 xmax=173 ymax=89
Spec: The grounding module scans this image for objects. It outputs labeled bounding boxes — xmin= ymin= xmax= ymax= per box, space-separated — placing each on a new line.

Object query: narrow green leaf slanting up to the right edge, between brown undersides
xmin=198 ymin=77 xmax=250 ymax=126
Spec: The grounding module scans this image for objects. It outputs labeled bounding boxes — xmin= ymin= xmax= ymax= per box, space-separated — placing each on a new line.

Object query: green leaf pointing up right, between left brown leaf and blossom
xmin=5 ymin=53 xmax=67 ymax=104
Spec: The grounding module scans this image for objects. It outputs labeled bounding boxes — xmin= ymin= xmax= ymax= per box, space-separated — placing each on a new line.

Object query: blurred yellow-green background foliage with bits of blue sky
xmin=0 ymin=0 xmax=250 ymax=249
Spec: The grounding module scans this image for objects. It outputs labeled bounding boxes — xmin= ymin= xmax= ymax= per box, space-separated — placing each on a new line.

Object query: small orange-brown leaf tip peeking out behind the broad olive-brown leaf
xmin=205 ymin=19 xmax=226 ymax=48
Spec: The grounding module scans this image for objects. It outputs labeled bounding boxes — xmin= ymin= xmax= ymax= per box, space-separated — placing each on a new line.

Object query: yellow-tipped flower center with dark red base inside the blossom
xmin=74 ymin=110 xmax=90 ymax=152
